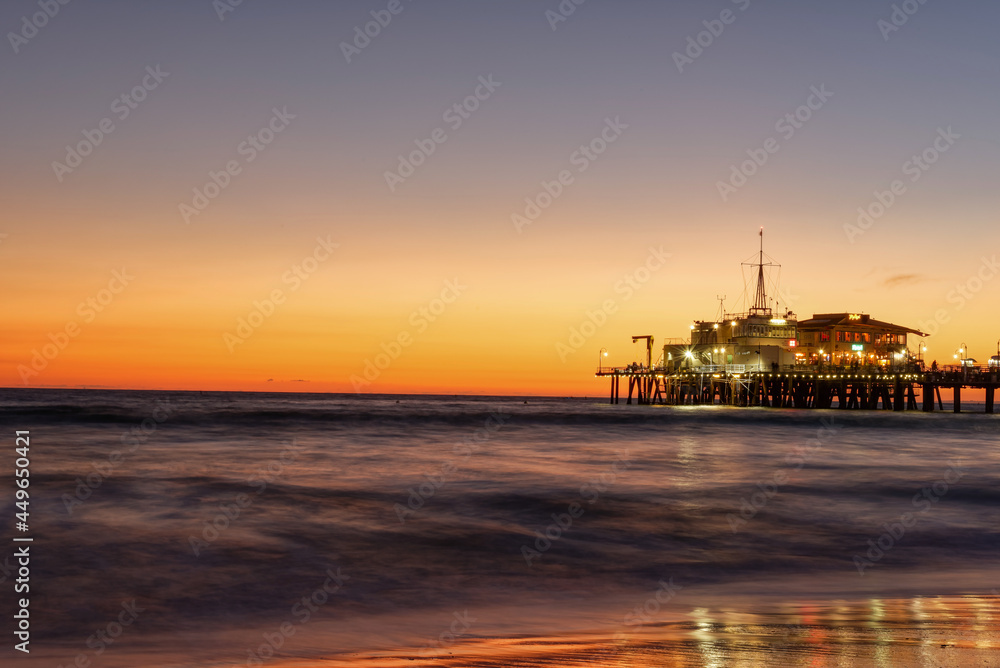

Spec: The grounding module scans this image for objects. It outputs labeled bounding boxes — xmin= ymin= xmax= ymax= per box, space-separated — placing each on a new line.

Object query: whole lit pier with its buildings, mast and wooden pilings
xmin=596 ymin=228 xmax=1000 ymax=414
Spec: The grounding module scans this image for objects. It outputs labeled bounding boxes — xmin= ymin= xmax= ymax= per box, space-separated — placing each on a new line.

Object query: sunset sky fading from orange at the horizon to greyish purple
xmin=0 ymin=0 xmax=1000 ymax=396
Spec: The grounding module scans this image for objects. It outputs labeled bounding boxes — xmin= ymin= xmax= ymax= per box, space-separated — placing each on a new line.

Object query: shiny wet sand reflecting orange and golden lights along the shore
xmin=21 ymin=594 xmax=1000 ymax=668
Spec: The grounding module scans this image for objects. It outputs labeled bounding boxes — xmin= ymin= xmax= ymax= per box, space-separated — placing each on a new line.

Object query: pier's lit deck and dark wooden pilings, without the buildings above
xmin=596 ymin=365 xmax=1000 ymax=413
